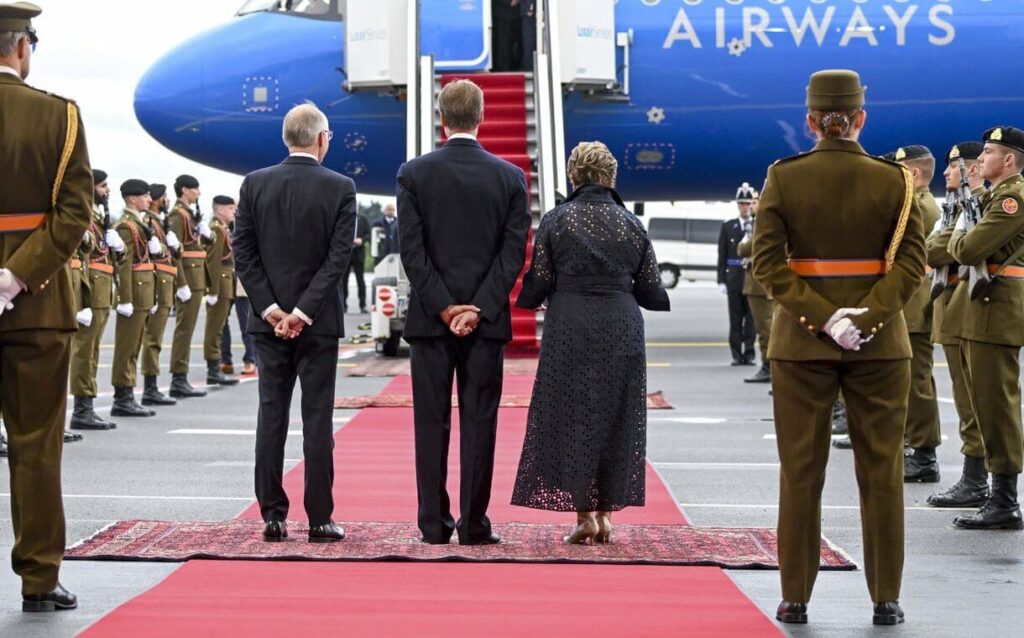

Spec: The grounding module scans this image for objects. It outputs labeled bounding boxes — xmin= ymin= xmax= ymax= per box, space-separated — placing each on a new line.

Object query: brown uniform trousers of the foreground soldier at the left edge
xmin=0 ymin=330 xmax=72 ymax=595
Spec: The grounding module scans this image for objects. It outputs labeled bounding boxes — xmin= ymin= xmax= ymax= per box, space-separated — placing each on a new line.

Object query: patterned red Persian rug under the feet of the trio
xmin=66 ymin=519 xmax=857 ymax=569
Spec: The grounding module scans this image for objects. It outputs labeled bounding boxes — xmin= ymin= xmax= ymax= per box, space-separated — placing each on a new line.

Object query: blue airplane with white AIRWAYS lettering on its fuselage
xmin=135 ymin=0 xmax=1024 ymax=201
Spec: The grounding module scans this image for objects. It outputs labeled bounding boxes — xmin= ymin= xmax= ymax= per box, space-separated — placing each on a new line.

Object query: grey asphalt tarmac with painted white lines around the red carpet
xmin=0 ymin=283 xmax=1024 ymax=638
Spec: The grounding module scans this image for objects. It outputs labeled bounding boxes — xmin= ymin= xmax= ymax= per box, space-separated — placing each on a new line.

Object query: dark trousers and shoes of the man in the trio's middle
xmin=410 ymin=335 xmax=505 ymax=543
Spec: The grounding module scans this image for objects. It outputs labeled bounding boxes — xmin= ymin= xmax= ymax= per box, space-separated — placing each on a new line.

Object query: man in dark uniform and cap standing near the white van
xmin=718 ymin=187 xmax=757 ymax=366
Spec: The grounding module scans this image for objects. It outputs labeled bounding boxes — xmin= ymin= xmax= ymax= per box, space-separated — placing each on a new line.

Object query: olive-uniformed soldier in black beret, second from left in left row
xmin=111 ymin=179 xmax=163 ymax=417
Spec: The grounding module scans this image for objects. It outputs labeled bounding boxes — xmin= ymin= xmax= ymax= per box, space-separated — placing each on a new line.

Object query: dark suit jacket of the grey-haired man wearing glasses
xmin=233 ymin=157 xmax=355 ymax=337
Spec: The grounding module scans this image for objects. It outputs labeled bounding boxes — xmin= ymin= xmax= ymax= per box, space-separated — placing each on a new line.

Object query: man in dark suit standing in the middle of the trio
xmin=397 ymin=80 xmax=530 ymax=545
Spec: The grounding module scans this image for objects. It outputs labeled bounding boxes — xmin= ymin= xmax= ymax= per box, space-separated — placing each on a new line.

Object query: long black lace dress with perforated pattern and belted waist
xmin=512 ymin=184 xmax=669 ymax=512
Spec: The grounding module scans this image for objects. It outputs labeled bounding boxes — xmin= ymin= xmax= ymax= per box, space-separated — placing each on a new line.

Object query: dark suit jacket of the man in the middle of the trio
xmin=398 ymin=138 xmax=530 ymax=341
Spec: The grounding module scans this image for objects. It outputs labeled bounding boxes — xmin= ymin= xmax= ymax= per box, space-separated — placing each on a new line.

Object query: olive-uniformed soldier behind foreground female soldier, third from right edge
xmin=887 ymin=144 xmax=942 ymax=483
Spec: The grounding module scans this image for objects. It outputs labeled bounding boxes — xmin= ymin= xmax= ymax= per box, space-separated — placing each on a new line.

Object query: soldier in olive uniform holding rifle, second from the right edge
xmin=926 ymin=141 xmax=989 ymax=507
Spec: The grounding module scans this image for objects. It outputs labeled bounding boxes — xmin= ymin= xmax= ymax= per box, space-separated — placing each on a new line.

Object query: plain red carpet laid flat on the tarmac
xmin=82 ymin=377 xmax=779 ymax=638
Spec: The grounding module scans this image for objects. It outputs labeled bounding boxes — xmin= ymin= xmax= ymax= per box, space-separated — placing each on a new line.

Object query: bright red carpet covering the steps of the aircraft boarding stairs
xmin=441 ymin=73 xmax=538 ymax=352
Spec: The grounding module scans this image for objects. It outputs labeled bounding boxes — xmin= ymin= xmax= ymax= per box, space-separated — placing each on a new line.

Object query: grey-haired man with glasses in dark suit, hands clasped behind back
xmin=234 ymin=104 xmax=356 ymax=543
